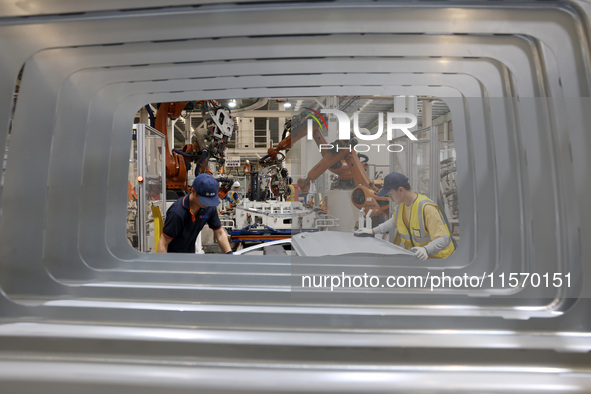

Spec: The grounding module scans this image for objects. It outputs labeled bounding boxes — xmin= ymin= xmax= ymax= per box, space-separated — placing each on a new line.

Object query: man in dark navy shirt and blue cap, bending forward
xmin=156 ymin=174 xmax=232 ymax=254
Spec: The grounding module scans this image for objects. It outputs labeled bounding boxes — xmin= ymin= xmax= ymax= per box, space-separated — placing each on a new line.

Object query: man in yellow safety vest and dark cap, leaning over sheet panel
xmin=354 ymin=172 xmax=455 ymax=260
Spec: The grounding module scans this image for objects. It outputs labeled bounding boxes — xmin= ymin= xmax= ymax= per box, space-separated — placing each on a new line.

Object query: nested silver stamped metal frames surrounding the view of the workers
xmin=0 ymin=0 xmax=591 ymax=394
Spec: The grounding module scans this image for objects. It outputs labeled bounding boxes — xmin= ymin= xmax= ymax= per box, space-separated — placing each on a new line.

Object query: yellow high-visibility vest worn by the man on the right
xmin=392 ymin=193 xmax=455 ymax=259
